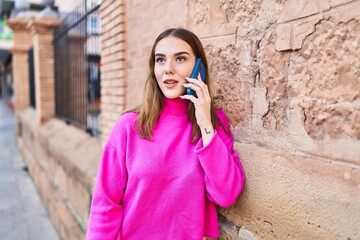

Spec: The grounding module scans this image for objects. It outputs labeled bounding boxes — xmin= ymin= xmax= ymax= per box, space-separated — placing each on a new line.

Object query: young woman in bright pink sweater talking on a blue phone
xmin=86 ymin=28 xmax=245 ymax=240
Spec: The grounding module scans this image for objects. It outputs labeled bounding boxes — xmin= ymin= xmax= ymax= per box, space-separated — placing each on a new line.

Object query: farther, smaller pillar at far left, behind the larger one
xmin=7 ymin=18 xmax=32 ymax=113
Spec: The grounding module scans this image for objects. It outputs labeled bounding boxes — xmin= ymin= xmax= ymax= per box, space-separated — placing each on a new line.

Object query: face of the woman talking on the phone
xmin=154 ymin=37 xmax=196 ymax=98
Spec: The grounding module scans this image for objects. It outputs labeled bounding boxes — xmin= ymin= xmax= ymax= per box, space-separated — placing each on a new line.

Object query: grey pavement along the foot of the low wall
xmin=0 ymin=98 xmax=60 ymax=240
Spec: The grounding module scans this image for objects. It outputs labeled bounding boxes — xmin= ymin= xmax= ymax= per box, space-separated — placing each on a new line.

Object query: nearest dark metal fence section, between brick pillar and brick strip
xmin=54 ymin=0 xmax=101 ymax=136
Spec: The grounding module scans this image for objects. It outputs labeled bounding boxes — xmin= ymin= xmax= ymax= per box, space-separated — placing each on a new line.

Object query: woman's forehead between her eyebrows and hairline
xmin=155 ymin=37 xmax=194 ymax=54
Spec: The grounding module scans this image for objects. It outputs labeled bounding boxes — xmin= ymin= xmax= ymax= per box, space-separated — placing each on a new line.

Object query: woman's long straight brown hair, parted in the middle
xmin=126 ymin=28 xmax=231 ymax=143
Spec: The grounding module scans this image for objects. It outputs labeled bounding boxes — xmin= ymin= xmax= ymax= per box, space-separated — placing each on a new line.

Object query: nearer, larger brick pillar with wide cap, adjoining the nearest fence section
xmin=30 ymin=17 xmax=61 ymax=125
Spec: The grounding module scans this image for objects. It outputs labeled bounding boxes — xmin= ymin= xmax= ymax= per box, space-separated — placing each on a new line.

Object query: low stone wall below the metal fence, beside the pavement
xmin=17 ymin=108 xmax=101 ymax=240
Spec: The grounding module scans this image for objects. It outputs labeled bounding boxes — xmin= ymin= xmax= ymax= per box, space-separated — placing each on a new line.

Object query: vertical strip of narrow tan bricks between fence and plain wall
xmin=100 ymin=0 xmax=126 ymax=144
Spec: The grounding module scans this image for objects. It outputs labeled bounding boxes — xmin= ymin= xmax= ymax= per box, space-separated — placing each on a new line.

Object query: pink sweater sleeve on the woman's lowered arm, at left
xmin=86 ymin=142 xmax=127 ymax=240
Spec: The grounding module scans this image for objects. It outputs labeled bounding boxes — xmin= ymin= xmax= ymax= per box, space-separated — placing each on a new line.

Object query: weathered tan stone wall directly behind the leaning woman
xmin=125 ymin=0 xmax=360 ymax=239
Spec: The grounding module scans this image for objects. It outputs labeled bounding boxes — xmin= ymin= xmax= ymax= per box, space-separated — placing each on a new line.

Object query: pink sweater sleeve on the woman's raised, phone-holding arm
xmin=195 ymin=111 xmax=245 ymax=207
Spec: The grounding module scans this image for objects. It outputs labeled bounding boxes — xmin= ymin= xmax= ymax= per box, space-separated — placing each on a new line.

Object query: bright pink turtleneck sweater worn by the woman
xmin=86 ymin=98 xmax=245 ymax=240
